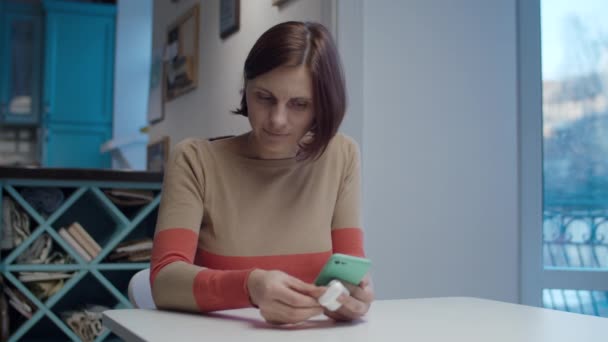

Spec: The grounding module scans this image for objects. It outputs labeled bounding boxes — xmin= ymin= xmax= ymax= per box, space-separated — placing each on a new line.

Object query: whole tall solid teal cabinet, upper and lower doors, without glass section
xmin=42 ymin=0 xmax=116 ymax=168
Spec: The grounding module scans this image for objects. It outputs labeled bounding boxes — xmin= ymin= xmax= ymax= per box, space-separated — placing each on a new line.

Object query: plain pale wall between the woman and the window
xmin=354 ymin=0 xmax=519 ymax=302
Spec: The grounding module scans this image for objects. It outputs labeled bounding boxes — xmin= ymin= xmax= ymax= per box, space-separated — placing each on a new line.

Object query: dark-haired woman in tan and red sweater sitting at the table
xmin=150 ymin=22 xmax=373 ymax=324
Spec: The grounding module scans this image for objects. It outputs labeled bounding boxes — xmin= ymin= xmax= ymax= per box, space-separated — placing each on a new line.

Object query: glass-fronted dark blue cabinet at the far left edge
xmin=0 ymin=1 xmax=42 ymax=125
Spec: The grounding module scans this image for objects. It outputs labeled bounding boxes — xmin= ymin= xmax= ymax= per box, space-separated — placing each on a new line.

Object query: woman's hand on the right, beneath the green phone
xmin=325 ymin=275 xmax=374 ymax=321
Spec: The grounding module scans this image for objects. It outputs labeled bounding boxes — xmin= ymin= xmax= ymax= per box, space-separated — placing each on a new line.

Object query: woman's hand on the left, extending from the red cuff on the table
xmin=247 ymin=269 xmax=323 ymax=324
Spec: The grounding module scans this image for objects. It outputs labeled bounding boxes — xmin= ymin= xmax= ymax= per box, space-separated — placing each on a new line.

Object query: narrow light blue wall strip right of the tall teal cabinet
xmin=113 ymin=0 xmax=152 ymax=170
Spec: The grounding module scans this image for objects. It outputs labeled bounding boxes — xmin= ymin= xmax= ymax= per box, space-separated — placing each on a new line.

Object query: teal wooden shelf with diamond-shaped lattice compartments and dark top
xmin=0 ymin=179 xmax=161 ymax=341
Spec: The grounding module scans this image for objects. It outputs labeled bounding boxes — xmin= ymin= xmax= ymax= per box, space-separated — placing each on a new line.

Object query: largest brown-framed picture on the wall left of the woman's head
xmin=163 ymin=4 xmax=200 ymax=102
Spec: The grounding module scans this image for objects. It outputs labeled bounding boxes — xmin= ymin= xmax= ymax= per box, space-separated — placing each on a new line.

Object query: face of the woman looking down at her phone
xmin=245 ymin=65 xmax=314 ymax=159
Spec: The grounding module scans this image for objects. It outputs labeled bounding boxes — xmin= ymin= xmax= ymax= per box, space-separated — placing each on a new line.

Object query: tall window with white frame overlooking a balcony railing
xmin=519 ymin=0 xmax=608 ymax=317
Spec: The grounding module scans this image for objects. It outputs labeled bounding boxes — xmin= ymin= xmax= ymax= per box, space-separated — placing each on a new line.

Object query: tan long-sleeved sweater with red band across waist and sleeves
xmin=150 ymin=134 xmax=364 ymax=312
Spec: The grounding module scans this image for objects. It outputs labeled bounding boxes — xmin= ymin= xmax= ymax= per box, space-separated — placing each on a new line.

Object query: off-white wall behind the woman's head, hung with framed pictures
xmin=150 ymin=0 xmax=329 ymax=145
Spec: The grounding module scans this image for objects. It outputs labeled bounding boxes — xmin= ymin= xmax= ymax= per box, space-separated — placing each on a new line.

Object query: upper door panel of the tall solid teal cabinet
xmin=43 ymin=1 xmax=115 ymax=125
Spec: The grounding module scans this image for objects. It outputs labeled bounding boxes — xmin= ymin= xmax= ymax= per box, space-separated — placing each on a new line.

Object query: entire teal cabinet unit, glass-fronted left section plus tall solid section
xmin=0 ymin=0 xmax=116 ymax=168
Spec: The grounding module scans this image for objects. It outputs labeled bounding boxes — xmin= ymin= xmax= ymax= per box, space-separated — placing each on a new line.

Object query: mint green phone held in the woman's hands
xmin=315 ymin=253 xmax=372 ymax=286
